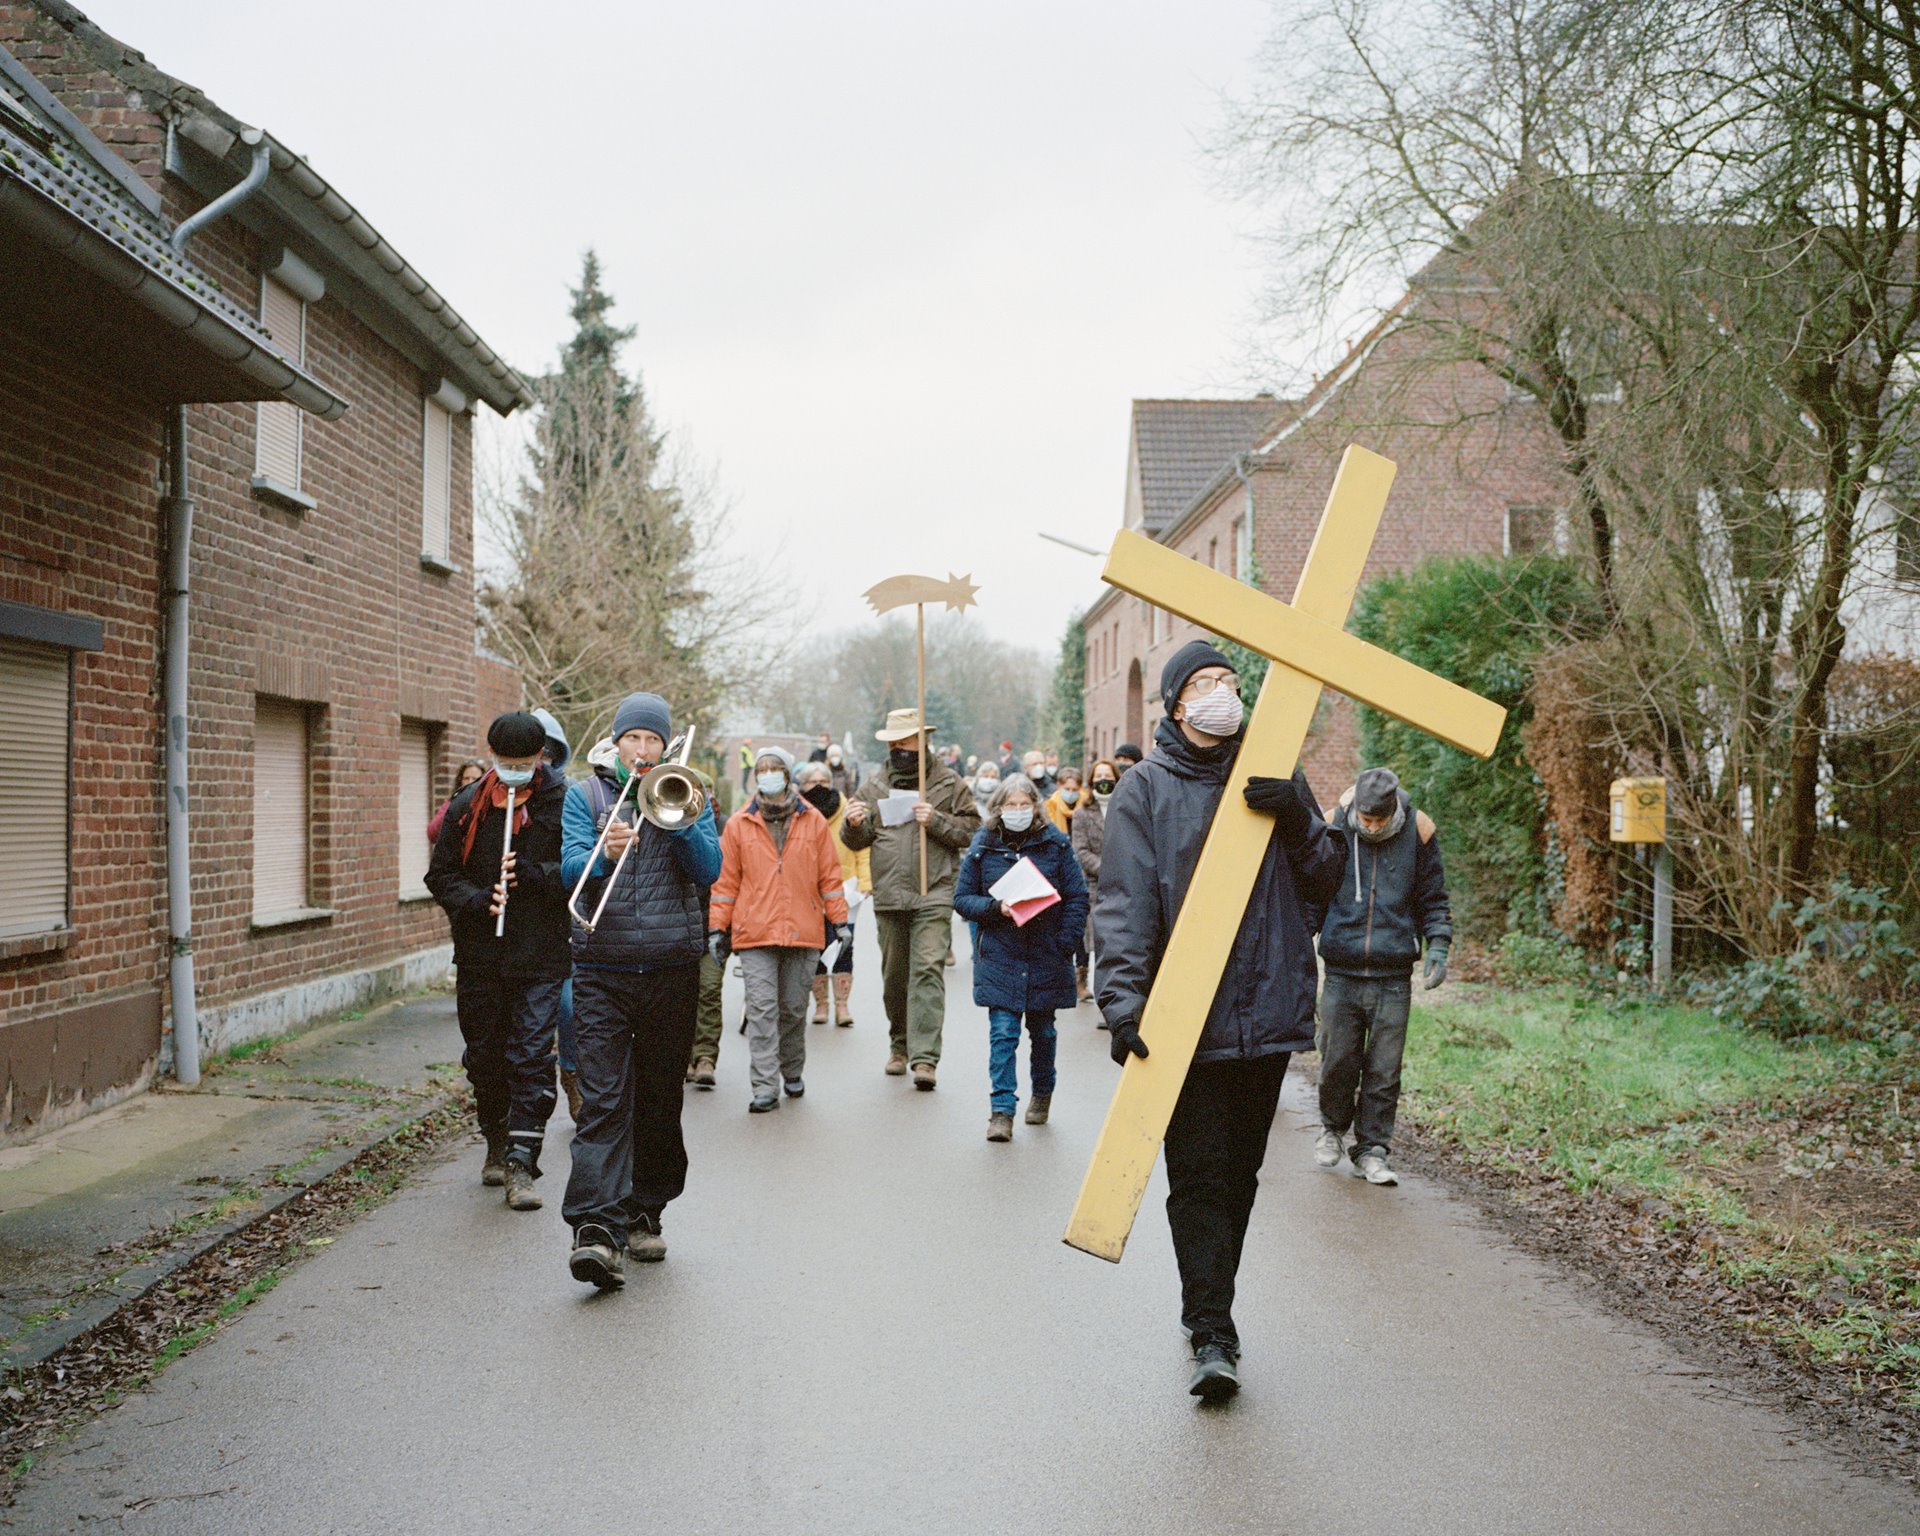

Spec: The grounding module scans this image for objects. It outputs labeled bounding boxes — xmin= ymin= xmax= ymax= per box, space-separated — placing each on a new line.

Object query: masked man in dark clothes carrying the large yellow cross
xmin=1094 ymin=639 xmax=1344 ymax=1400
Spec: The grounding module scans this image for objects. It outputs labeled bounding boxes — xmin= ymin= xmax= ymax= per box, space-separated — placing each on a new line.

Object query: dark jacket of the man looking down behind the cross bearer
xmin=1311 ymin=791 xmax=1453 ymax=977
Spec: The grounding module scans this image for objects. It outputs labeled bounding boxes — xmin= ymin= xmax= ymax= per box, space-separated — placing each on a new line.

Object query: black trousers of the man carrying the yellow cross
xmin=1167 ymin=1052 xmax=1290 ymax=1350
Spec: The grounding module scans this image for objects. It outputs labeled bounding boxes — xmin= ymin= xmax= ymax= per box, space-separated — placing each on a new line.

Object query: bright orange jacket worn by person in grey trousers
xmin=707 ymin=795 xmax=847 ymax=950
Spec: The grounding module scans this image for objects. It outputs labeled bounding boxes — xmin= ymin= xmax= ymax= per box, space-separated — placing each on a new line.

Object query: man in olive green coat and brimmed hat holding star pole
xmin=841 ymin=708 xmax=979 ymax=1089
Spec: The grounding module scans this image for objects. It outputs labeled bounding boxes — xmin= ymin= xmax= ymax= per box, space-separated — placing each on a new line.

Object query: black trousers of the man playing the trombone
xmin=561 ymin=960 xmax=701 ymax=1246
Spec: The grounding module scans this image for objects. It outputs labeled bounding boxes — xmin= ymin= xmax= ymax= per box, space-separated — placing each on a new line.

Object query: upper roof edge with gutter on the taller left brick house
xmin=20 ymin=0 xmax=534 ymax=415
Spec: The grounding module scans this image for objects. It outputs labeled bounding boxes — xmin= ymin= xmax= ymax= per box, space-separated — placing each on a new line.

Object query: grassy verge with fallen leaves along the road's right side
xmin=1404 ymin=990 xmax=1920 ymax=1478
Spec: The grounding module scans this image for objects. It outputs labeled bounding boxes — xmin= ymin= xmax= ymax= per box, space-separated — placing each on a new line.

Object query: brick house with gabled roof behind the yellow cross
xmin=1085 ymin=298 xmax=1567 ymax=801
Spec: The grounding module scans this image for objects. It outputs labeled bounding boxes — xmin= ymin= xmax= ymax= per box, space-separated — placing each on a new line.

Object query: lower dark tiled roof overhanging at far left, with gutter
xmin=0 ymin=48 xmax=346 ymax=417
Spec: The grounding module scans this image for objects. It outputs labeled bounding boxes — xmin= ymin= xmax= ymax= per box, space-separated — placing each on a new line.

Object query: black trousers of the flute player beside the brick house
xmin=453 ymin=966 xmax=566 ymax=1173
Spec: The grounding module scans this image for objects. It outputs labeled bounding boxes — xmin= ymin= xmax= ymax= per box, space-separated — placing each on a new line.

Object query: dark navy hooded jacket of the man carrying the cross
xmin=1092 ymin=720 xmax=1346 ymax=1062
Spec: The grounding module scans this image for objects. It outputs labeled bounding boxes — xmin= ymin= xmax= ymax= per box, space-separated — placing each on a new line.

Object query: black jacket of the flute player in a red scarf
xmin=426 ymin=764 xmax=572 ymax=981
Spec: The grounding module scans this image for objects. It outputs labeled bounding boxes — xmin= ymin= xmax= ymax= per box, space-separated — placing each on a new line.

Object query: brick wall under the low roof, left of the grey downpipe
xmin=0 ymin=332 xmax=167 ymax=1131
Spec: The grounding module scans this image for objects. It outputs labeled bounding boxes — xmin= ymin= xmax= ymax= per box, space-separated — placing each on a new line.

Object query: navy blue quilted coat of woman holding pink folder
xmin=954 ymin=818 xmax=1087 ymax=1014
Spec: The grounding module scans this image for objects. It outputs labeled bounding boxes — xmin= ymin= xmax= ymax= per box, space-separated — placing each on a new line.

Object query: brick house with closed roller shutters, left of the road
xmin=0 ymin=0 xmax=532 ymax=1139
